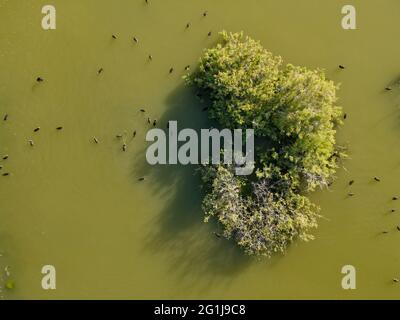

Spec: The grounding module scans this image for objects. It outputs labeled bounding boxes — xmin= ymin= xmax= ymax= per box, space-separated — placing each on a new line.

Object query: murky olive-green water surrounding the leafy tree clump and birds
xmin=0 ymin=0 xmax=400 ymax=299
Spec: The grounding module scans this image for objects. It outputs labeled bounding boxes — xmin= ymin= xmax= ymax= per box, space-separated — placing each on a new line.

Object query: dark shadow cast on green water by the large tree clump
xmin=133 ymin=85 xmax=252 ymax=292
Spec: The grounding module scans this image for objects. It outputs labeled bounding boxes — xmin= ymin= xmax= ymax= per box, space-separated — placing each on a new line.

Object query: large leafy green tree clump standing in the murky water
xmin=187 ymin=32 xmax=344 ymax=256
